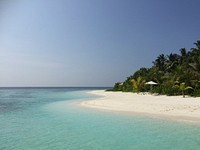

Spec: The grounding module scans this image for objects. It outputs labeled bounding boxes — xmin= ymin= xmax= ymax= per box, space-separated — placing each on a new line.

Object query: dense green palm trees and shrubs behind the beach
xmin=111 ymin=41 xmax=200 ymax=97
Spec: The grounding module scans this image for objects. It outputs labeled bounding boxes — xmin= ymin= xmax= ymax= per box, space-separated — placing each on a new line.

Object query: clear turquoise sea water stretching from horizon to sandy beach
xmin=0 ymin=88 xmax=200 ymax=150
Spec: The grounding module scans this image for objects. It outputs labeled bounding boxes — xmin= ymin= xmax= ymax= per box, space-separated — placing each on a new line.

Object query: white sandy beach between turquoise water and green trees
xmin=81 ymin=90 xmax=200 ymax=122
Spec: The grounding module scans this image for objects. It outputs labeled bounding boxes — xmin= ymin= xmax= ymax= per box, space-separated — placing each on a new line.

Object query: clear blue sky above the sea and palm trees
xmin=0 ymin=0 xmax=200 ymax=87
